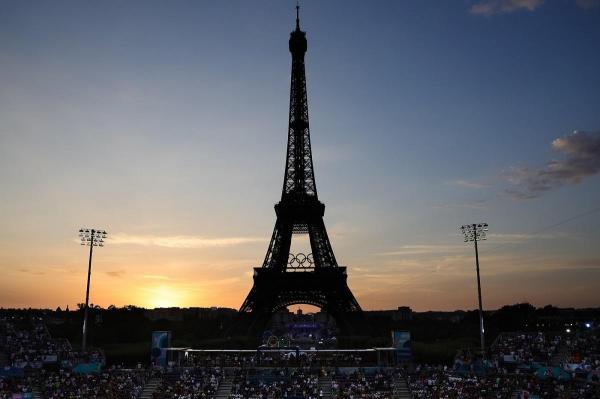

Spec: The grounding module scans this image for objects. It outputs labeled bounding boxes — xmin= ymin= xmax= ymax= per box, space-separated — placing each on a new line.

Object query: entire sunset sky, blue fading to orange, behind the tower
xmin=0 ymin=0 xmax=600 ymax=311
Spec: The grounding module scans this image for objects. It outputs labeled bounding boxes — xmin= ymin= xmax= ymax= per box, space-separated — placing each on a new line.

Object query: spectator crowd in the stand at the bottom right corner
xmin=406 ymin=330 xmax=600 ymax=399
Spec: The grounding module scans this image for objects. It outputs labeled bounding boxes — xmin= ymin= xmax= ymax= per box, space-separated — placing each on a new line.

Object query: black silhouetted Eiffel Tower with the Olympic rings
xmin=240 ymin=6 xmax=361 ymax=330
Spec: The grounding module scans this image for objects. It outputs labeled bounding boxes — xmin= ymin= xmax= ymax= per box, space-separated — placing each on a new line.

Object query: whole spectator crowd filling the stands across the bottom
xmin=0 ymin=317 xmax=600 ymax=399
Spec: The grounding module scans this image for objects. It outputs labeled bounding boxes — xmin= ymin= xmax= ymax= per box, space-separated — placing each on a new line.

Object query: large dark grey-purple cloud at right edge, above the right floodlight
xmin=503 ymin=131 xmax=600 ymax=199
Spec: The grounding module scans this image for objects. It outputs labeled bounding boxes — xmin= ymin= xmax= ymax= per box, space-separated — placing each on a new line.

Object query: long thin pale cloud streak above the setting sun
xmin=110 ymin=233 xmax=266 ymax=248
